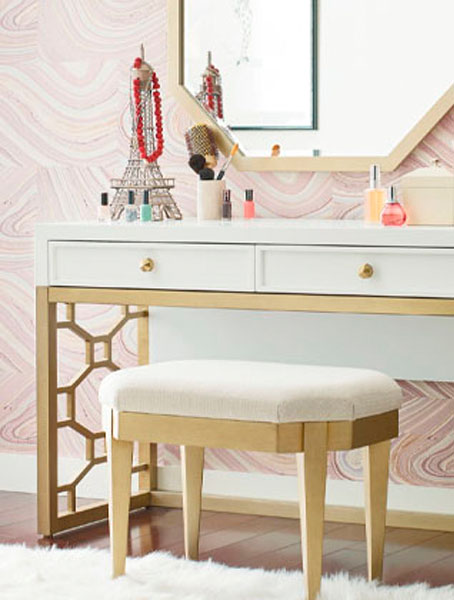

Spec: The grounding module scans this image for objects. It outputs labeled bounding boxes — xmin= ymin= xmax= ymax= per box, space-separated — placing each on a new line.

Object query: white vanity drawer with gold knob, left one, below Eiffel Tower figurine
xmin=48 ymin=242 xmax=254 ymax=291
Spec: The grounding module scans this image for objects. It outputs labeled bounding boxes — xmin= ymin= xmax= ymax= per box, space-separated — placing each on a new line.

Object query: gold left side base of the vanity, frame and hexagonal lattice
xmin=37 ymin=288 xmax=156 ymax=535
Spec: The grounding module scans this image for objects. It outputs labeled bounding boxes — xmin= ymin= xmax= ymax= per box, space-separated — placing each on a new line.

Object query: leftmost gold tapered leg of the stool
xmin=107 ymin=436 xmax=133 ymax=577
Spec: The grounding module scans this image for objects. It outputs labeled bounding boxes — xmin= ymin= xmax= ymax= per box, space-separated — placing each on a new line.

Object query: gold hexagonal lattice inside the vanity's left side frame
xmin=57 ymin=304 xmax=148 ymax=512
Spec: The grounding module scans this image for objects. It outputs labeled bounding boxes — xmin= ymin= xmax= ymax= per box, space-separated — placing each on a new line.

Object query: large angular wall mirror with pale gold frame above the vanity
xmin=169 ymin=0 xmax=454 ymax=171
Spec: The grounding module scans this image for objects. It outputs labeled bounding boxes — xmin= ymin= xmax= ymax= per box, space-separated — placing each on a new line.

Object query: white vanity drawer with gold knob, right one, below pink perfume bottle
xmin=256 ymin=246 xmax=454 ymax=297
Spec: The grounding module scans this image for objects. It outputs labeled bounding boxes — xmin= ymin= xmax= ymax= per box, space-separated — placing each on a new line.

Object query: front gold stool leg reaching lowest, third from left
xmin=296 ymin=423 xmax=328 ymax=600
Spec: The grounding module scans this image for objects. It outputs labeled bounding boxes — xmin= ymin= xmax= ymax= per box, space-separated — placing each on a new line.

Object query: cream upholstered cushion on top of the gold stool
xmin=99 ymin=360 xmax=402 ymax=423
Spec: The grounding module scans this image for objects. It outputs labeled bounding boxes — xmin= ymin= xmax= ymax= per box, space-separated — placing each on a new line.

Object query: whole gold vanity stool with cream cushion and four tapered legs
xmin=100 ymin=360 xmax=401 ymax=600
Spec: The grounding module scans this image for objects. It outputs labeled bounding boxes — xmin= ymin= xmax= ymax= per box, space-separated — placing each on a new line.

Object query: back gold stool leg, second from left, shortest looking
xmin=181 ymin=446 xmax=204 ymax=560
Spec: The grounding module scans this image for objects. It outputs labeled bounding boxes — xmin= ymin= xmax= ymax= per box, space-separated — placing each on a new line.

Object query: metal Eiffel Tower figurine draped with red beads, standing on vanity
xmin=110 ymin=45 xmax=182 ymax=221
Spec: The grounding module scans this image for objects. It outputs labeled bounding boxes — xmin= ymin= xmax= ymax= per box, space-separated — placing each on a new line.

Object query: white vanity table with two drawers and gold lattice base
xmin=36 ymin=219 xmax=454 ymax=535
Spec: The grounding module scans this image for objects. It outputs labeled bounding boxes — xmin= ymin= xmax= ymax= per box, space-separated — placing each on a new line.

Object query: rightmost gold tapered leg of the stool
xmin=364 ymin=440 xmax=391 ymax=581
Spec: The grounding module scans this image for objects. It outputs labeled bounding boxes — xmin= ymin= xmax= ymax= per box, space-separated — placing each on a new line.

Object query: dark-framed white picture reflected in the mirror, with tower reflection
xmin=184 ymin=0 xmax=316 ymax=129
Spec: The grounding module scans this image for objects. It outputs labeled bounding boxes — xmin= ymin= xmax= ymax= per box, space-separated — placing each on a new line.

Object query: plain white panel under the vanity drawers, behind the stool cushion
xmin=151 ymin=308 xmax=454 ymax=381
